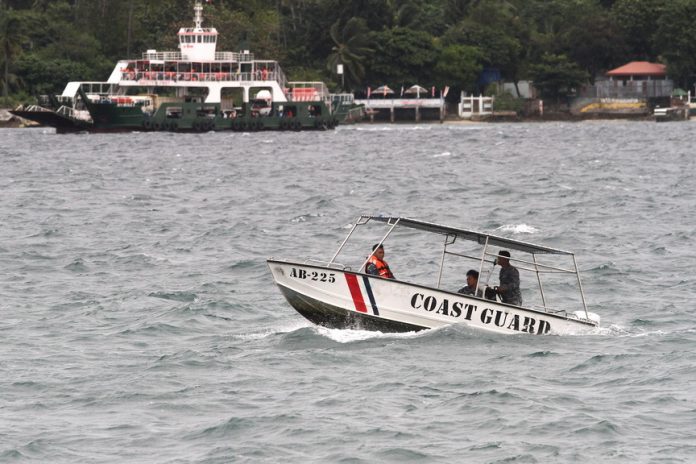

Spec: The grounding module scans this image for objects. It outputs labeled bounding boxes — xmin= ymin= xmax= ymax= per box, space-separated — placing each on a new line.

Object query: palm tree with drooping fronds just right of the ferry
xmin=326 ymin=17 xmax=373 ymax=89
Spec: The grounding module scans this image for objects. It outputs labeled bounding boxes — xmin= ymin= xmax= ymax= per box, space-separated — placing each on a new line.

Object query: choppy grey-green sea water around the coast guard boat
xmin=0 ymin=122 xmax=696 ymax=463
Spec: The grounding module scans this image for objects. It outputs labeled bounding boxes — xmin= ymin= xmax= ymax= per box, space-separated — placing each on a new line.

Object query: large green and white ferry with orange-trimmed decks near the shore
xmin=12 ymin=0 xmax=339 ymax=132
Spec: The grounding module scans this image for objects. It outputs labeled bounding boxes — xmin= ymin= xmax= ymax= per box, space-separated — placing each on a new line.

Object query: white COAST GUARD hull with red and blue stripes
xmin=268 ymin=260 xmax=597 ymax=335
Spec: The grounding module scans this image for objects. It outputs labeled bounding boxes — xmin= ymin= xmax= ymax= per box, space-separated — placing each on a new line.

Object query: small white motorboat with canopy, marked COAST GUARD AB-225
xmin=267 ymin=216 xmax=600 ymax=335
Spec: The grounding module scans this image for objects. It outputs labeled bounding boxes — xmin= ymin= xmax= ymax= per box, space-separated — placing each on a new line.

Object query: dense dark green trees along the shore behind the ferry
xmin=0 ymin=0 xmax=696 ymax=103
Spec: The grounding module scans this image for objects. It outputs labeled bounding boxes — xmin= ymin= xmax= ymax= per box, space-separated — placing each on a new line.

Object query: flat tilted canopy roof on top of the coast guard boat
xmin=368 ymin=216 xmax=573 ymax=255
